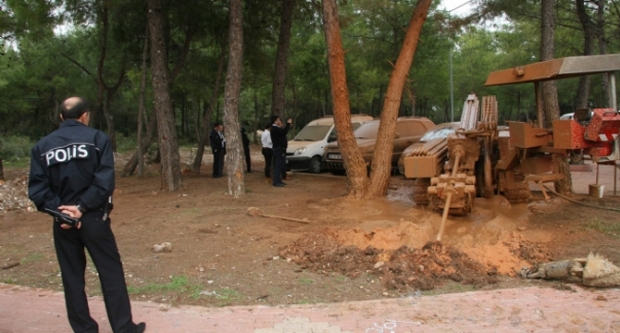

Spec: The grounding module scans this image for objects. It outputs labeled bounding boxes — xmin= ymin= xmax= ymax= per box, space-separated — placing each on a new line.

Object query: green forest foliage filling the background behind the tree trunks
xmin=0 ymin=0 xmax=620 ymax=141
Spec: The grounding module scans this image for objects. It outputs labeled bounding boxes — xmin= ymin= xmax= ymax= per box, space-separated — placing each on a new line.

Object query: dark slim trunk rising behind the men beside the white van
xmin=271 ymin=0 xmax=295 ymax=118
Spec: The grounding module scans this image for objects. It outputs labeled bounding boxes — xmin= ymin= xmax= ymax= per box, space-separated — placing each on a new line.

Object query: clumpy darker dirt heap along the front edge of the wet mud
xmin=279 ymin=229 xmax=497 ymax=290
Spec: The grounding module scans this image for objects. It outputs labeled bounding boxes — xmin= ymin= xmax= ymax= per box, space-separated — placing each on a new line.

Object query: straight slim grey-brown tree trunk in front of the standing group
xmin=224 ymin=0 xmax=245 ymax=198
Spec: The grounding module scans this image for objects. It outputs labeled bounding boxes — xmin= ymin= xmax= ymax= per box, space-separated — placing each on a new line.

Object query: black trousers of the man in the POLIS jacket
xmin=54 ymin=211 xmax=136 ymax=333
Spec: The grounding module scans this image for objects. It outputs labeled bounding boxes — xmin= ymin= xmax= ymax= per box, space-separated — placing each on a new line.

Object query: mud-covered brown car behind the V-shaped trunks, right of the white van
xmin=324 ymin=117 xmax=435 ymax=174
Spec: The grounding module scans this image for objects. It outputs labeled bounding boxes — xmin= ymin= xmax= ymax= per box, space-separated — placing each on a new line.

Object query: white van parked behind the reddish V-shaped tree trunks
xmin=286 ymin=114 xmax=372 ymax=173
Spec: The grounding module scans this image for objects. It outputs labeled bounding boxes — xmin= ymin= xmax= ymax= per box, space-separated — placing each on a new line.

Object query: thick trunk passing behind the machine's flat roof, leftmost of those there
xmin=540 ymin=0 xmax=572 ymax=195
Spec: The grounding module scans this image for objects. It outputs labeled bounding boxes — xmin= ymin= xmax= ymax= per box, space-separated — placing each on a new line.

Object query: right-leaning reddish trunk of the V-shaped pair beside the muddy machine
xmin=367 ymin=0 xmax=432 ymax=197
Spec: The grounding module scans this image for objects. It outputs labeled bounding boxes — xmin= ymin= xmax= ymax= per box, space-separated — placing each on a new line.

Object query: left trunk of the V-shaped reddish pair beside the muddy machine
xmin=323 ymin=0 xmax=368 ymax=199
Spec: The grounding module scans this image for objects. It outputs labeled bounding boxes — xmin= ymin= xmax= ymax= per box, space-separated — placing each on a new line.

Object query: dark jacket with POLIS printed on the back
xmin=28 ymin=119 xmax=114 ymax=211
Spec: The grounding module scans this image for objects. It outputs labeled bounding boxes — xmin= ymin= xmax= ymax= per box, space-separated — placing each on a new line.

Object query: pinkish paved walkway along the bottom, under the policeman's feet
xmin=0 ymin=284 xmax=620 ymax=333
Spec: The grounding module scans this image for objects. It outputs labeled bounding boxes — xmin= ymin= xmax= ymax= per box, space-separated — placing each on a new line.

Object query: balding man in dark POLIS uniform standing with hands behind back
xmin=28 ymin=97 xmax=146 ymax=333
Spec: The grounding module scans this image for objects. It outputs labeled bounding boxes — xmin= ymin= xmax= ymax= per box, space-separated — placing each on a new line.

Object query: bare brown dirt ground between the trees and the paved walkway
xmin=0 ymin=147 xmax=620 ymax=306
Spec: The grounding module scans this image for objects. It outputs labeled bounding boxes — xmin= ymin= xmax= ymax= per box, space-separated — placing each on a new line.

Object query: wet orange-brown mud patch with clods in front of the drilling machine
xmin=280 ymin=196 xmax=551 ymax=290
